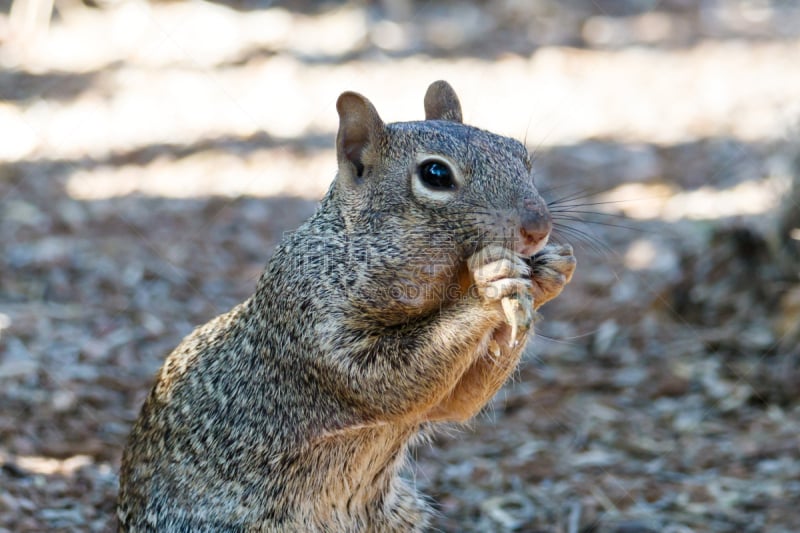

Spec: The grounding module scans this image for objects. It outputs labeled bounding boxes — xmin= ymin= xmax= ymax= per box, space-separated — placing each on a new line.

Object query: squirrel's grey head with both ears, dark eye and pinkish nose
xmin=334 ymin=81 xmax=552 ymax=259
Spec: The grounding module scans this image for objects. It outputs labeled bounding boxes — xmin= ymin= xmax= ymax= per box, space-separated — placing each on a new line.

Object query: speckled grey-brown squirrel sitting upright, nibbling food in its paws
xmin=117 ymin=81 xmax=576 ymax=532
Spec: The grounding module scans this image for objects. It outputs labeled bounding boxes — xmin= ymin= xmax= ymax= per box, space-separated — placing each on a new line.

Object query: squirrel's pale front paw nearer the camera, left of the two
xmin=468 ymin=246 xmax=534 ymax=346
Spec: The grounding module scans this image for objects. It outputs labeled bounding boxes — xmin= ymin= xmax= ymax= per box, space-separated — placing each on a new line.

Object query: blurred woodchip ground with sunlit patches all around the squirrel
xmin=0 ymin=0 xmax=800 ymax=533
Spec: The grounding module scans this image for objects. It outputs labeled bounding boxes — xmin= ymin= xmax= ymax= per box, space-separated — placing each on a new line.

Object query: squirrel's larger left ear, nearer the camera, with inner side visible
xmin=336 ymin=91 xmax=384 ymax=177
